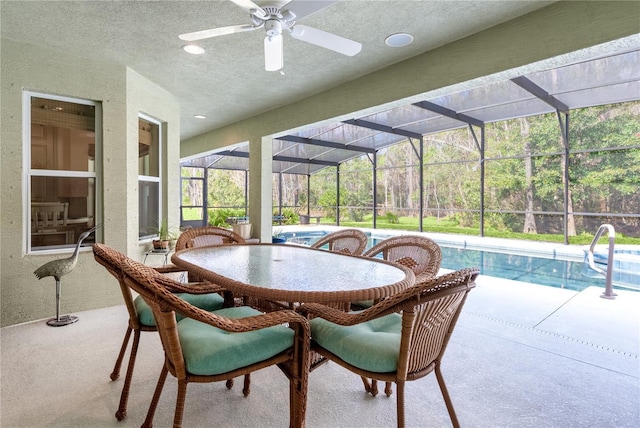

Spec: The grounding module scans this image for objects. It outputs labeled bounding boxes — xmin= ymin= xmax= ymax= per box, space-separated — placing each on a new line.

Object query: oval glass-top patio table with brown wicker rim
xmin=171 ymin=244 xmax=415 ymax=304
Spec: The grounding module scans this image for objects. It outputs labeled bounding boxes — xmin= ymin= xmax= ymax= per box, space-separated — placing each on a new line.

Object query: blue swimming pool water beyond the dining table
xmin=282 ymin=229 xmax=640 ymax=291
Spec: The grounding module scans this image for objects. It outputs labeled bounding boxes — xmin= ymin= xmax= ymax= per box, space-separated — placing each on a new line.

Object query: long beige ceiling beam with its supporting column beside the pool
xmin=181 ymin=1 xmax=640 ymax=239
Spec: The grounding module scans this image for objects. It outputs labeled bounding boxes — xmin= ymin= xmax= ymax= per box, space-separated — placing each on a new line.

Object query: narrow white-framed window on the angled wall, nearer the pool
xmin=138 ymin=115 xmax=162 ymax=239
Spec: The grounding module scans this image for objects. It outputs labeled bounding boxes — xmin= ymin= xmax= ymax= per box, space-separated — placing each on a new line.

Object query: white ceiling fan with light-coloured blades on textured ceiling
xmin=178 ymin=0 xmax=362 ymax=71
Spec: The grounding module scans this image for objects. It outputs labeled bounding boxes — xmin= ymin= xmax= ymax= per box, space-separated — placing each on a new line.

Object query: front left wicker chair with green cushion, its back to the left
xmin=122 ymin=258 xmax=310 ymax=427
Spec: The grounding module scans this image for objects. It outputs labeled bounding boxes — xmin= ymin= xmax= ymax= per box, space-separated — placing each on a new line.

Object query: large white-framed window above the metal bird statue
xmin=24 ymin=92 xmax=101 ymax=253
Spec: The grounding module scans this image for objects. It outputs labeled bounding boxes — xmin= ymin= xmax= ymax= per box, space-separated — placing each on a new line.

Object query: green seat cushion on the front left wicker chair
xmin=178 ymin=306 xmax=294 ymax=375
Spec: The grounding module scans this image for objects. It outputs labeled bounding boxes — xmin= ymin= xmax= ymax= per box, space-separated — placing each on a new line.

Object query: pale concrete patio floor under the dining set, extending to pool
xmin=0 ymin=276 xmax=640 ymax=428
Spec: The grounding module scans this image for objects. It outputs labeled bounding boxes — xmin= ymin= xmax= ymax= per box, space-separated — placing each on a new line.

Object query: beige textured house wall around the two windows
xmin=0 ymin=39 xmax=180 ymax=326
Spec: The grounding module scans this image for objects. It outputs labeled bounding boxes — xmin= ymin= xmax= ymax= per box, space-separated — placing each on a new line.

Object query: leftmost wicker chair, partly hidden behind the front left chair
xmin=93 ymin=244 xmax=235 ymax=421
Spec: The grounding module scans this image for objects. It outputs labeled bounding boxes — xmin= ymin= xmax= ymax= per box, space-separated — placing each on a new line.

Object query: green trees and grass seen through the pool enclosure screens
xmin=199 ymin=102 xmax=640 ymax=244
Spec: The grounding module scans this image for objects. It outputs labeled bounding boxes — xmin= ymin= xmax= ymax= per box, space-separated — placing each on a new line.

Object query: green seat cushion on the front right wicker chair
xmin=311 ymin=314 xmax=402 ymax=373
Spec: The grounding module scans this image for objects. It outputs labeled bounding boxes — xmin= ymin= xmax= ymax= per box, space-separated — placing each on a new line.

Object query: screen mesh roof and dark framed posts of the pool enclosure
xmin=182 ymin=50 xmax=640 ymax=243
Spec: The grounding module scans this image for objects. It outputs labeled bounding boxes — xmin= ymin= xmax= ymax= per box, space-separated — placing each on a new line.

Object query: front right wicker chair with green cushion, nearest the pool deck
xmin=298 ymin=268 xmax=479 ymax=427
